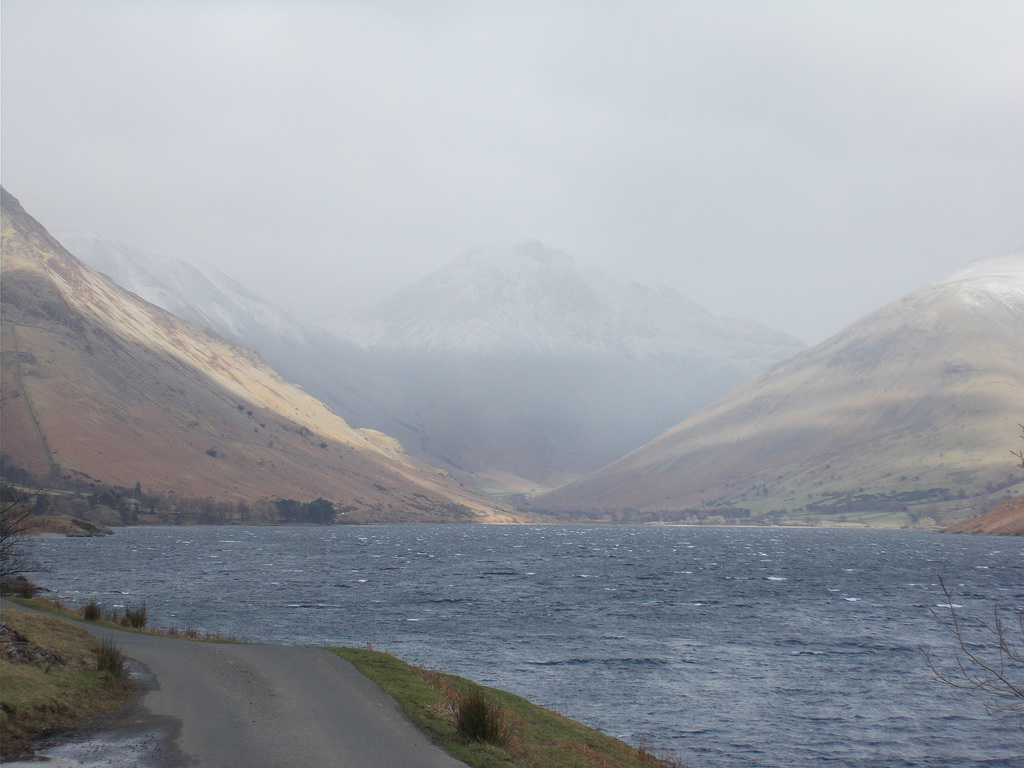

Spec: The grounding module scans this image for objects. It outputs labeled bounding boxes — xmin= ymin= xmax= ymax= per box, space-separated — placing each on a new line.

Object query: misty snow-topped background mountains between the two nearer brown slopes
xmin=67 ymin=236 xmax=803 ymax=494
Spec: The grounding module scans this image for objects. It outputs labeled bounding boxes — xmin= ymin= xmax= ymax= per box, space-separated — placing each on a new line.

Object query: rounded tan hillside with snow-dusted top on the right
xmin=536 ymin=252 xmax=1024 ymax=524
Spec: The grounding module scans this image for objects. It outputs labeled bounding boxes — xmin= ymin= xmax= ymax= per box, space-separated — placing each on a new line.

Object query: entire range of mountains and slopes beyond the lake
xmin=3 ymin=191 xmax=1024 ymax=527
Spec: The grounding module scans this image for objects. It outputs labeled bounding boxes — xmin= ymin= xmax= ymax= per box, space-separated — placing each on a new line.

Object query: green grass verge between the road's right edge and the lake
xmin=332 ymin=648 xmax=682 ymax=768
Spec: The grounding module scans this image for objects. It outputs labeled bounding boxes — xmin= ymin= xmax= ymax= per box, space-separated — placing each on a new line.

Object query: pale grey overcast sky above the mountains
xmin=0 ymin=0 xmax=1024 ymax=343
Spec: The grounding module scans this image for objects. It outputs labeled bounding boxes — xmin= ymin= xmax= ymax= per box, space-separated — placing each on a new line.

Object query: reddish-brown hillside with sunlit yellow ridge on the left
xmin=0 ymin=190 xmax=511 ymax=521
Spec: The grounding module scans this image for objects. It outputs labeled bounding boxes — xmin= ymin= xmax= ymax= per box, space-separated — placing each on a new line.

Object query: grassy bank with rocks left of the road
xmin=0 ymin=610 xmax=131 ymax=759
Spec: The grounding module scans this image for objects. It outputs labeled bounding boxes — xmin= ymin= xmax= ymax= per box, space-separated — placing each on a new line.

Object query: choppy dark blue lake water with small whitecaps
xmin=24 ymin=525 xmax=1024 ymax=768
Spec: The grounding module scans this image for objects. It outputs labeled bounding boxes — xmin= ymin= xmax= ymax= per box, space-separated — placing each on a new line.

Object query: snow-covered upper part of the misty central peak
xmin=322 ymin=240 xmax=804 ymax=364
